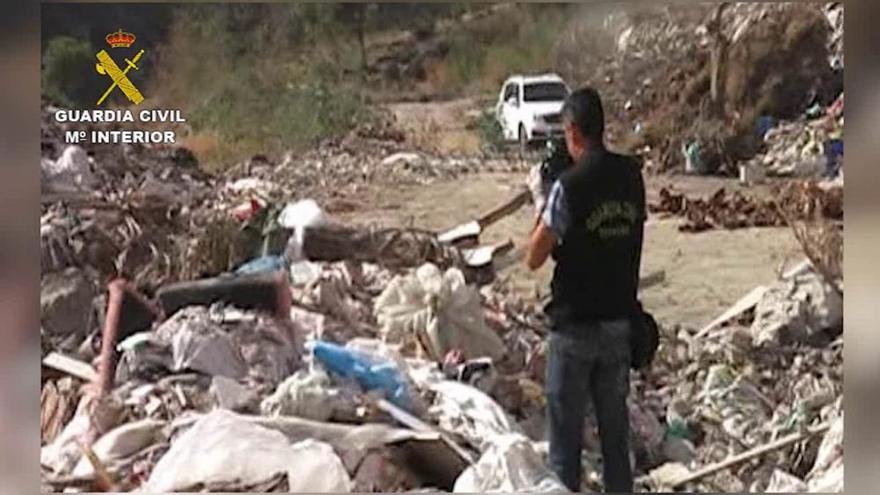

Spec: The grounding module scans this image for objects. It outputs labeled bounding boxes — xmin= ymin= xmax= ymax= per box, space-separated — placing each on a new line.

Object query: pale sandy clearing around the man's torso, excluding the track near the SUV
xmin=338 ymin=174 xmax=801 ymax=327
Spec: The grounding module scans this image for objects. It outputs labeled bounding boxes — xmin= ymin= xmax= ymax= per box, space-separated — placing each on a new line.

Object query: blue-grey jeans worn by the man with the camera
xmin=545 ymin=320 xmax=633 ymax=493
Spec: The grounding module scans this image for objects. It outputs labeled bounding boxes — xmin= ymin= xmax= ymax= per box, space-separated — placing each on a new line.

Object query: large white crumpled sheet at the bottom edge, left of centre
xmin=143 ymin=409 xmax=352 ymax=493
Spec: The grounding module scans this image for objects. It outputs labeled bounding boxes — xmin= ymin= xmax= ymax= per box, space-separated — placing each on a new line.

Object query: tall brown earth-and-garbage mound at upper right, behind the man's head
xmin=557 ymin=3 xmax=843 ymax=175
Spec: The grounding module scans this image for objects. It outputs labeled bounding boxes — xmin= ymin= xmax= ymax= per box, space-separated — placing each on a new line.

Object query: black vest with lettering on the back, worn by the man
xmin=546 ymin=151 xmax=646 ymax=328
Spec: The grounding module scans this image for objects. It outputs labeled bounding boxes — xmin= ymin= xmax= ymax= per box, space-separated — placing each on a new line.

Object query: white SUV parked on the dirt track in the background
xmin=495 ymin=74 xmax=569 ymax=151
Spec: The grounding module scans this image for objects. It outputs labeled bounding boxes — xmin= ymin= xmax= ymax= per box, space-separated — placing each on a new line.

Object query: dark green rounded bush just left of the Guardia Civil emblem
xmin=41 ymin=36 xmax=98 ymax=106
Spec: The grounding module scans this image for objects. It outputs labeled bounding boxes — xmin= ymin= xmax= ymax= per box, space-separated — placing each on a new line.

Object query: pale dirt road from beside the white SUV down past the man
xmin=360 ymin=99 xmax=801 ymax=327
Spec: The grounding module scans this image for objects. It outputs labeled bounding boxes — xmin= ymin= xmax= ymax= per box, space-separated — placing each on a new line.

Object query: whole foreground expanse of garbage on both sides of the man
xmin=40 ymin=101 xmax=843 ymax=492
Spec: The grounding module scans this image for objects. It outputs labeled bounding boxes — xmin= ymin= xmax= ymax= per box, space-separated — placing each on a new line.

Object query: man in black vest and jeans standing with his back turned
xmin=526 ymin=88 xmax=646 ymax=493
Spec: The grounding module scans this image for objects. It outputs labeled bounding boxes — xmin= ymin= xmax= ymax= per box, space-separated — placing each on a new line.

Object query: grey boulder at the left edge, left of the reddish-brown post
xmin=40 ymin=267 xmax=97 ymax=337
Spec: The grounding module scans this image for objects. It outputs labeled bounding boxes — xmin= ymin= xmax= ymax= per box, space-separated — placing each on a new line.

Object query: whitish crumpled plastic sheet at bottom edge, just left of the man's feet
xmin=453 ymin=433 xmax=568 ymax=493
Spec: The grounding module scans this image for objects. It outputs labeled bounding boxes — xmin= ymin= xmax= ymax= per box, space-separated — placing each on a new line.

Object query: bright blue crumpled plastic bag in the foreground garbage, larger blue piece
xmin=312 ymin=340 xmax=412 ymax=411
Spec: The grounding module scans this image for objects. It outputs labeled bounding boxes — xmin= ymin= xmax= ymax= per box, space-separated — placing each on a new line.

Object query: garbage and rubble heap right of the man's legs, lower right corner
xmin=638 ymin=262 xmax=843 ymax=492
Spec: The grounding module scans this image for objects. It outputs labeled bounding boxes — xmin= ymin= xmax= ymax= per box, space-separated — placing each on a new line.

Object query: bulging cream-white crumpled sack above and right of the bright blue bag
xmin=374 ymin=263 xmax=505 ymax=360
